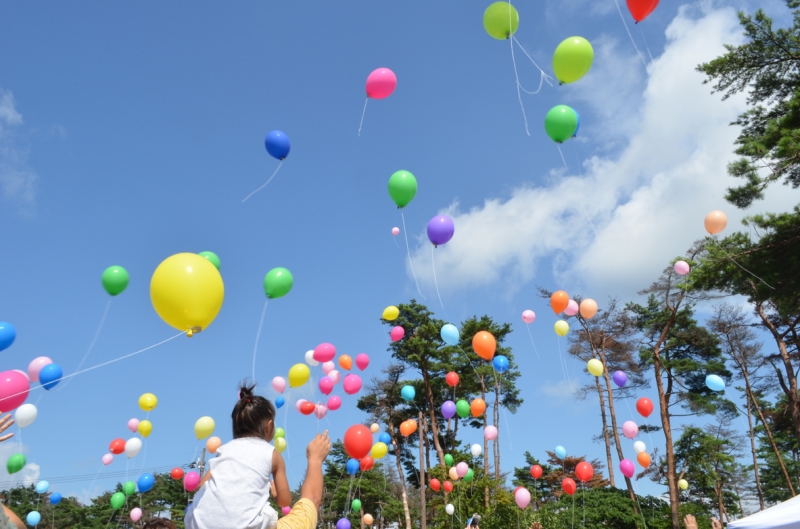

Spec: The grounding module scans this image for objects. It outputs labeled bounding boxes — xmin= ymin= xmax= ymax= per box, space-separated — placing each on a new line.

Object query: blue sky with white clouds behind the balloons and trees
xmin=0 ymin=0 xmax=793 ymax=504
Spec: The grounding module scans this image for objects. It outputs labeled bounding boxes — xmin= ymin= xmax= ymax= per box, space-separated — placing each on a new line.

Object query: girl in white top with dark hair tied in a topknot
xmin=185 ymin=384 xmax=292 ymax=529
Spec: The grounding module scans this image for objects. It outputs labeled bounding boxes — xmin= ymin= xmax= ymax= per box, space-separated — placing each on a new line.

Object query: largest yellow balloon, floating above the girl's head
xmin=150 ymin=253 xmax=225 ymax=333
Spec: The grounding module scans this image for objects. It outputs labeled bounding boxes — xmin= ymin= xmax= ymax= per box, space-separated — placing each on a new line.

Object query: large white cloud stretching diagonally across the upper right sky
xmin=413 ymin=6 xmax=796 ymax=299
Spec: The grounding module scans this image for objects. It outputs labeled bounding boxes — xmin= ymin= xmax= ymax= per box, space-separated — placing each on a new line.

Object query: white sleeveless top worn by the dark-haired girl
xmin=185 ymin=437 xmax=277 ymax=529
